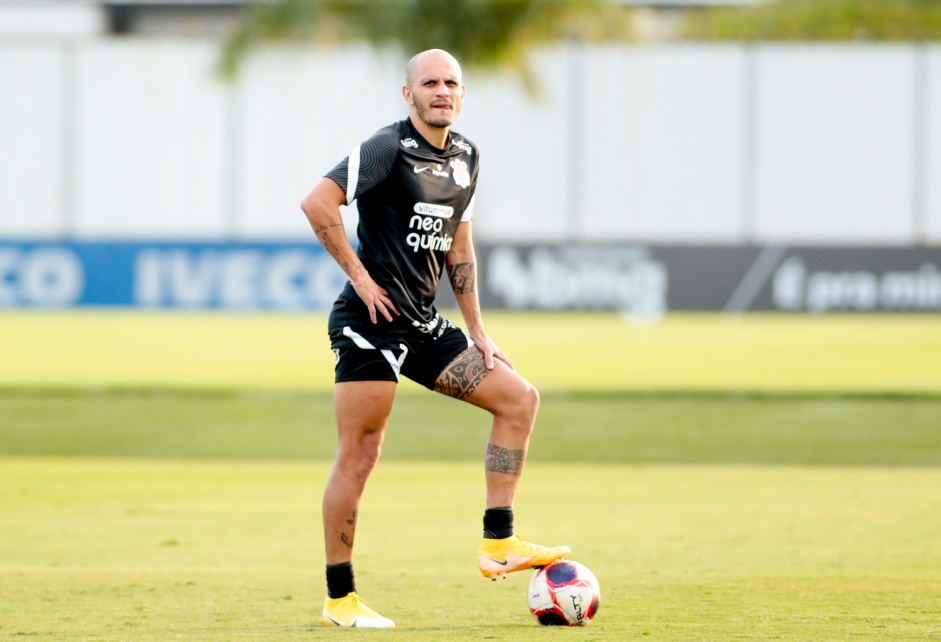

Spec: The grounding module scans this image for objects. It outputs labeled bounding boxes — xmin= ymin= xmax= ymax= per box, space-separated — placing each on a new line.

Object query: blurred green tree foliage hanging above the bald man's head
xmin=220 ymin=0 xmax=630 ymax=77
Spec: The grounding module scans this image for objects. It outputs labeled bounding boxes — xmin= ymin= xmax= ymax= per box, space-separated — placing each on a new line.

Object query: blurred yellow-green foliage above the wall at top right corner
xmin=682 ymin=0 xmax=941 ymax=41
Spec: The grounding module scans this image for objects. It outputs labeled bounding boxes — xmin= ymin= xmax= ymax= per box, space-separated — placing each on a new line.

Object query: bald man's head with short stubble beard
xmin=404 ymin=53 xmax=464 ymax=127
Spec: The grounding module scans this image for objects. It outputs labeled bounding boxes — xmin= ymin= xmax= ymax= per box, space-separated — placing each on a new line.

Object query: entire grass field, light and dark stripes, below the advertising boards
xmin=0 ymin=312 xmax=941 ymax=642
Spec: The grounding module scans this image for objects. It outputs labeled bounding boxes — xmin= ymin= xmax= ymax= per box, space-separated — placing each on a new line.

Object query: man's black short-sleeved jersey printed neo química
xmin=327 ymin=119 xmax=479 ymax=328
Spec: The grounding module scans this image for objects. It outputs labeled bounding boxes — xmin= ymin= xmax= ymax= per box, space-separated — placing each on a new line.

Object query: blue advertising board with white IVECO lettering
xmin=0 ymin=240 xmax=345 ymax=310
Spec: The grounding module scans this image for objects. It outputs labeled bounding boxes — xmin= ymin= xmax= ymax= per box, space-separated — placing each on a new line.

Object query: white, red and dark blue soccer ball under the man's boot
xmin=528 ymin=560 xmax=601 ymax=626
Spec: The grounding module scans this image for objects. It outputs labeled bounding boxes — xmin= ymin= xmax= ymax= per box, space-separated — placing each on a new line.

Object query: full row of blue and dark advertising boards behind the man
xmin=0 ymin=239 xmax=941 ymax=317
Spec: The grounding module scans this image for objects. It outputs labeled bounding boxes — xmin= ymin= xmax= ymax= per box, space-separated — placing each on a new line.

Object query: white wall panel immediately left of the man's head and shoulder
xmin=230 ymin=48 xmax=404 ymax=238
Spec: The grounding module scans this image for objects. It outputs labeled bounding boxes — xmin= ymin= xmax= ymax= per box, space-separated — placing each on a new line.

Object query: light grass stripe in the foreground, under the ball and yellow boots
xmin=0 ymin=457 xmax=941 ymax=642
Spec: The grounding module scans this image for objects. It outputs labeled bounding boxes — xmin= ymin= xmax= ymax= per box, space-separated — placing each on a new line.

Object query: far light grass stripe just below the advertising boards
xmin=0 ymin=311 xmax=941 ymax=395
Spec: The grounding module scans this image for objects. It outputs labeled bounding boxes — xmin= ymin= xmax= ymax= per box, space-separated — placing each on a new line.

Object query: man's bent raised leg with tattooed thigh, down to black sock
xmin=435 ymin=346 xmax=539 ymax=508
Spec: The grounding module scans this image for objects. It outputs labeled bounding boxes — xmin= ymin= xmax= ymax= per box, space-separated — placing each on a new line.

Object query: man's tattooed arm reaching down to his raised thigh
xmin=444 ymin=221 xmax=513 ymax=370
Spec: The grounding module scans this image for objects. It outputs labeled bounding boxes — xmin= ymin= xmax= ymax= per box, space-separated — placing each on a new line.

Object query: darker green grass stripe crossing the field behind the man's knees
xmin=0 ymin=393 xmax=941 ymax=466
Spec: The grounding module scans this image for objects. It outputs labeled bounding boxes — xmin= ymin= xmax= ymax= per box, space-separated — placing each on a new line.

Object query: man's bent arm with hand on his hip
xmin=301 ymin=178 xmax=399 ymax=323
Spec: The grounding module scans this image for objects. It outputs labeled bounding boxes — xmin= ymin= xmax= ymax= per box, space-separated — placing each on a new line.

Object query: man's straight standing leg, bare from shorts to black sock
xmin=323 ymin=381 xmax=396 ymax=564
